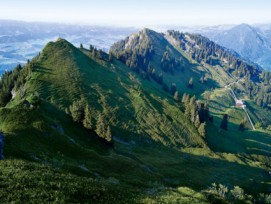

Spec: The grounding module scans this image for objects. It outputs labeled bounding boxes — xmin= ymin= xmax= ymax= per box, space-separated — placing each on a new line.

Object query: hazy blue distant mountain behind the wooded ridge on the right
xmin=190 ymin=24 xmax=271 ymax=70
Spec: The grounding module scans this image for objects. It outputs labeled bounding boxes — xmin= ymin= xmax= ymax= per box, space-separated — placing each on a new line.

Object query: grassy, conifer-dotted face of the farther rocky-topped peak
xmin=110 ymin=29 xmax=225 ymax=95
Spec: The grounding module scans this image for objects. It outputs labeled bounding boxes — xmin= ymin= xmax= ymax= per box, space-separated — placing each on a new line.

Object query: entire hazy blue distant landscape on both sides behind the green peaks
xmin=0 ymin=20 xmax=271 ymax=74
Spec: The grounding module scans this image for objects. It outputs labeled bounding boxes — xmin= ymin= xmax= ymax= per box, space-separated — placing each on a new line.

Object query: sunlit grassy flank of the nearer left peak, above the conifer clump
xmin=28 ymin=40 xmax=204 ymax=146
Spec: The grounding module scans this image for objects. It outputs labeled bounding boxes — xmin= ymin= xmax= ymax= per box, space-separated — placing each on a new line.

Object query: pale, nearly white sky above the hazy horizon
xmin=0 ymin=0 xmax=271 ymax=26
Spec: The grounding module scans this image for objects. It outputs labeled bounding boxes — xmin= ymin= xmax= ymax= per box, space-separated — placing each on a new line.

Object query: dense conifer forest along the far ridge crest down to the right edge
xmin=168 ymin=30 xmax=271 ymax=108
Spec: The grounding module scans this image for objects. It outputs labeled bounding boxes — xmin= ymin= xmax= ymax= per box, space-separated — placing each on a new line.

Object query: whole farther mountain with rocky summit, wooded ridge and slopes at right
xmin=111 ymin=29 xmax=270 ymax=151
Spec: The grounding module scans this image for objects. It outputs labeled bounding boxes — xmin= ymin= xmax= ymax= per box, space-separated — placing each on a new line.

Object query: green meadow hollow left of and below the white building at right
xmin=207 ymin=88 xmax=271 ymax=156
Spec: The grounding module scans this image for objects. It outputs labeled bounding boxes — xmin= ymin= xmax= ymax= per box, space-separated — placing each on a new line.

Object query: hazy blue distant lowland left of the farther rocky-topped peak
xmin=0 ymin=20 xmax=136 ymax=74
